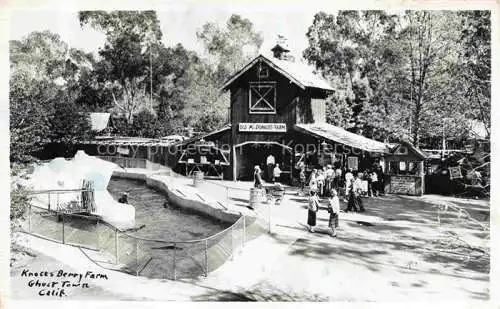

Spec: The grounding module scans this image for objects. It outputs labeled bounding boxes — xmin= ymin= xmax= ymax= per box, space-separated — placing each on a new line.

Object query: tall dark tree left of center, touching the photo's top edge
xmin=79 ymin=11 xmax=162 ymax=125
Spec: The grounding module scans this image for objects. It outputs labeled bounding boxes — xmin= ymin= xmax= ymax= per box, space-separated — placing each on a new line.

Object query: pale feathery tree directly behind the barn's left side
xmin=184 ymin=14 xmax=263 ymax=132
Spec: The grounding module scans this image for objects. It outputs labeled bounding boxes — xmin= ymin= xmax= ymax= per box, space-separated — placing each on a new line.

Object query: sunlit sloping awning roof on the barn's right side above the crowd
xmin=294 ymin=123 xmax=390 ymax=153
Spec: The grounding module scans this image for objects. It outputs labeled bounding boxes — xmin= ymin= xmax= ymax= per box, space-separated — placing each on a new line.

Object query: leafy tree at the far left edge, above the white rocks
xmin=10 ymin=31 xmax=92 ymax=162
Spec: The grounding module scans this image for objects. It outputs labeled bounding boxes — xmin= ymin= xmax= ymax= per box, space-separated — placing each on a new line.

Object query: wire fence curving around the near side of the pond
xmin=22 ymin=205 xmax=267 ymax=280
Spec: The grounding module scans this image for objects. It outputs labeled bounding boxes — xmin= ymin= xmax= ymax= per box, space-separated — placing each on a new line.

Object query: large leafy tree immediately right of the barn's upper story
xmin=303 ymin=11 xmax=395 ymax=136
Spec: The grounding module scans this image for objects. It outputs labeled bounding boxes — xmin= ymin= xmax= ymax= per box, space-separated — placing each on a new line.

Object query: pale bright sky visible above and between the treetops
xmin=10 ymin=5 xmax=335 ymax=58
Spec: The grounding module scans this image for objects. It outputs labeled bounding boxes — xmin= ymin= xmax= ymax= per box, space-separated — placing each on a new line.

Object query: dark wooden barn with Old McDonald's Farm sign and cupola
xmin=178 ymin=44 xmax=390 ymax=183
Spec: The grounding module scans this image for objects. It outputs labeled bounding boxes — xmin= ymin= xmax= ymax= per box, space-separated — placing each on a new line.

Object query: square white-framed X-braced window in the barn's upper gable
xmin=249 ymin=82 xmax=276 ymax=114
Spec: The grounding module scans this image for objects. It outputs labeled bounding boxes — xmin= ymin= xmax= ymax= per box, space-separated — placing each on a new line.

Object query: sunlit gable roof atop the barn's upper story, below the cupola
xmin=221 ymin=55 xmax=333 ymax=91
